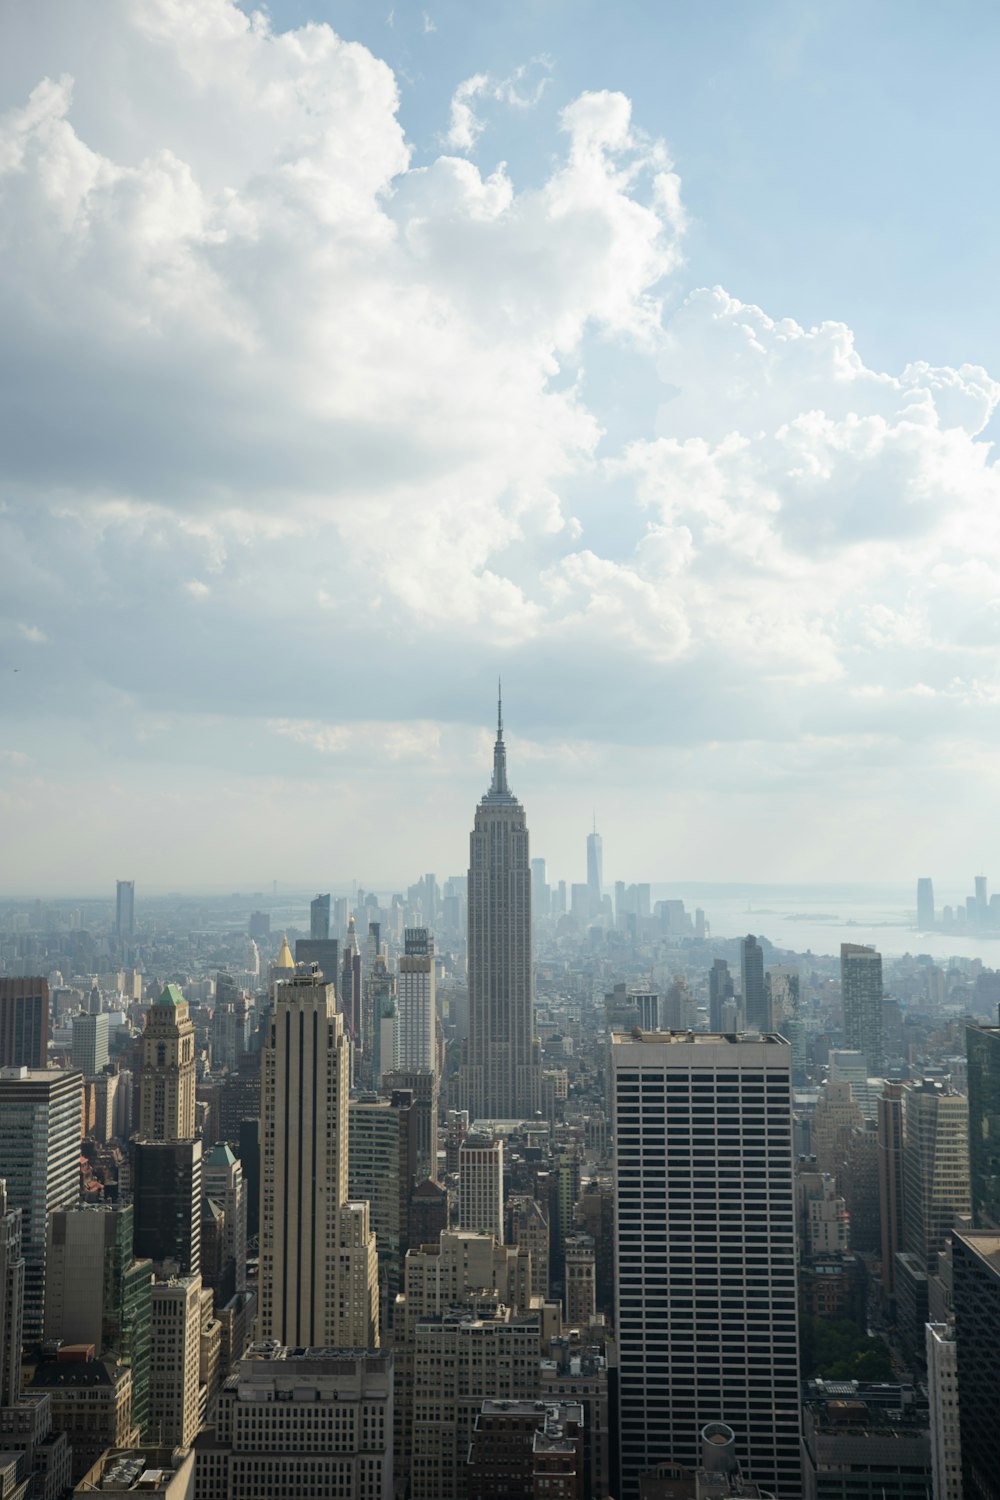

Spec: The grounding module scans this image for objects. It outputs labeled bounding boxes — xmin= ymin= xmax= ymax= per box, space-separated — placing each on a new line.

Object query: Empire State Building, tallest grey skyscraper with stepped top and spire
xmin=463 ymin=705 xmax=541 ymax=1119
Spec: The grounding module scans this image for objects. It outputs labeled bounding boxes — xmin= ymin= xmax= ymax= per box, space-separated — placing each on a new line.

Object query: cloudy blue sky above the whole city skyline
xmin=0 ymin=0 xmax=1000 ymax=894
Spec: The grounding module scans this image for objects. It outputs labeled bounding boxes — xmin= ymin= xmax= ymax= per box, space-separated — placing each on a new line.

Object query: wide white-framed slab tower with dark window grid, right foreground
xmin=612 ymin=1032 xmax=802 ymax=1500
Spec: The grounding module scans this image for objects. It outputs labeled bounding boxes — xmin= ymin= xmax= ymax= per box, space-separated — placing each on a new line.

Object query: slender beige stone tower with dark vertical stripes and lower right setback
xmin=259 ymin=968 xmax=378 ymax=1349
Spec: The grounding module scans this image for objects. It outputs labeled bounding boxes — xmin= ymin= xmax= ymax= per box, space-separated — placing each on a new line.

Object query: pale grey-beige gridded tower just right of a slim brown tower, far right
xmin=903 ymin=1079 xmax=970 ymax=1272
